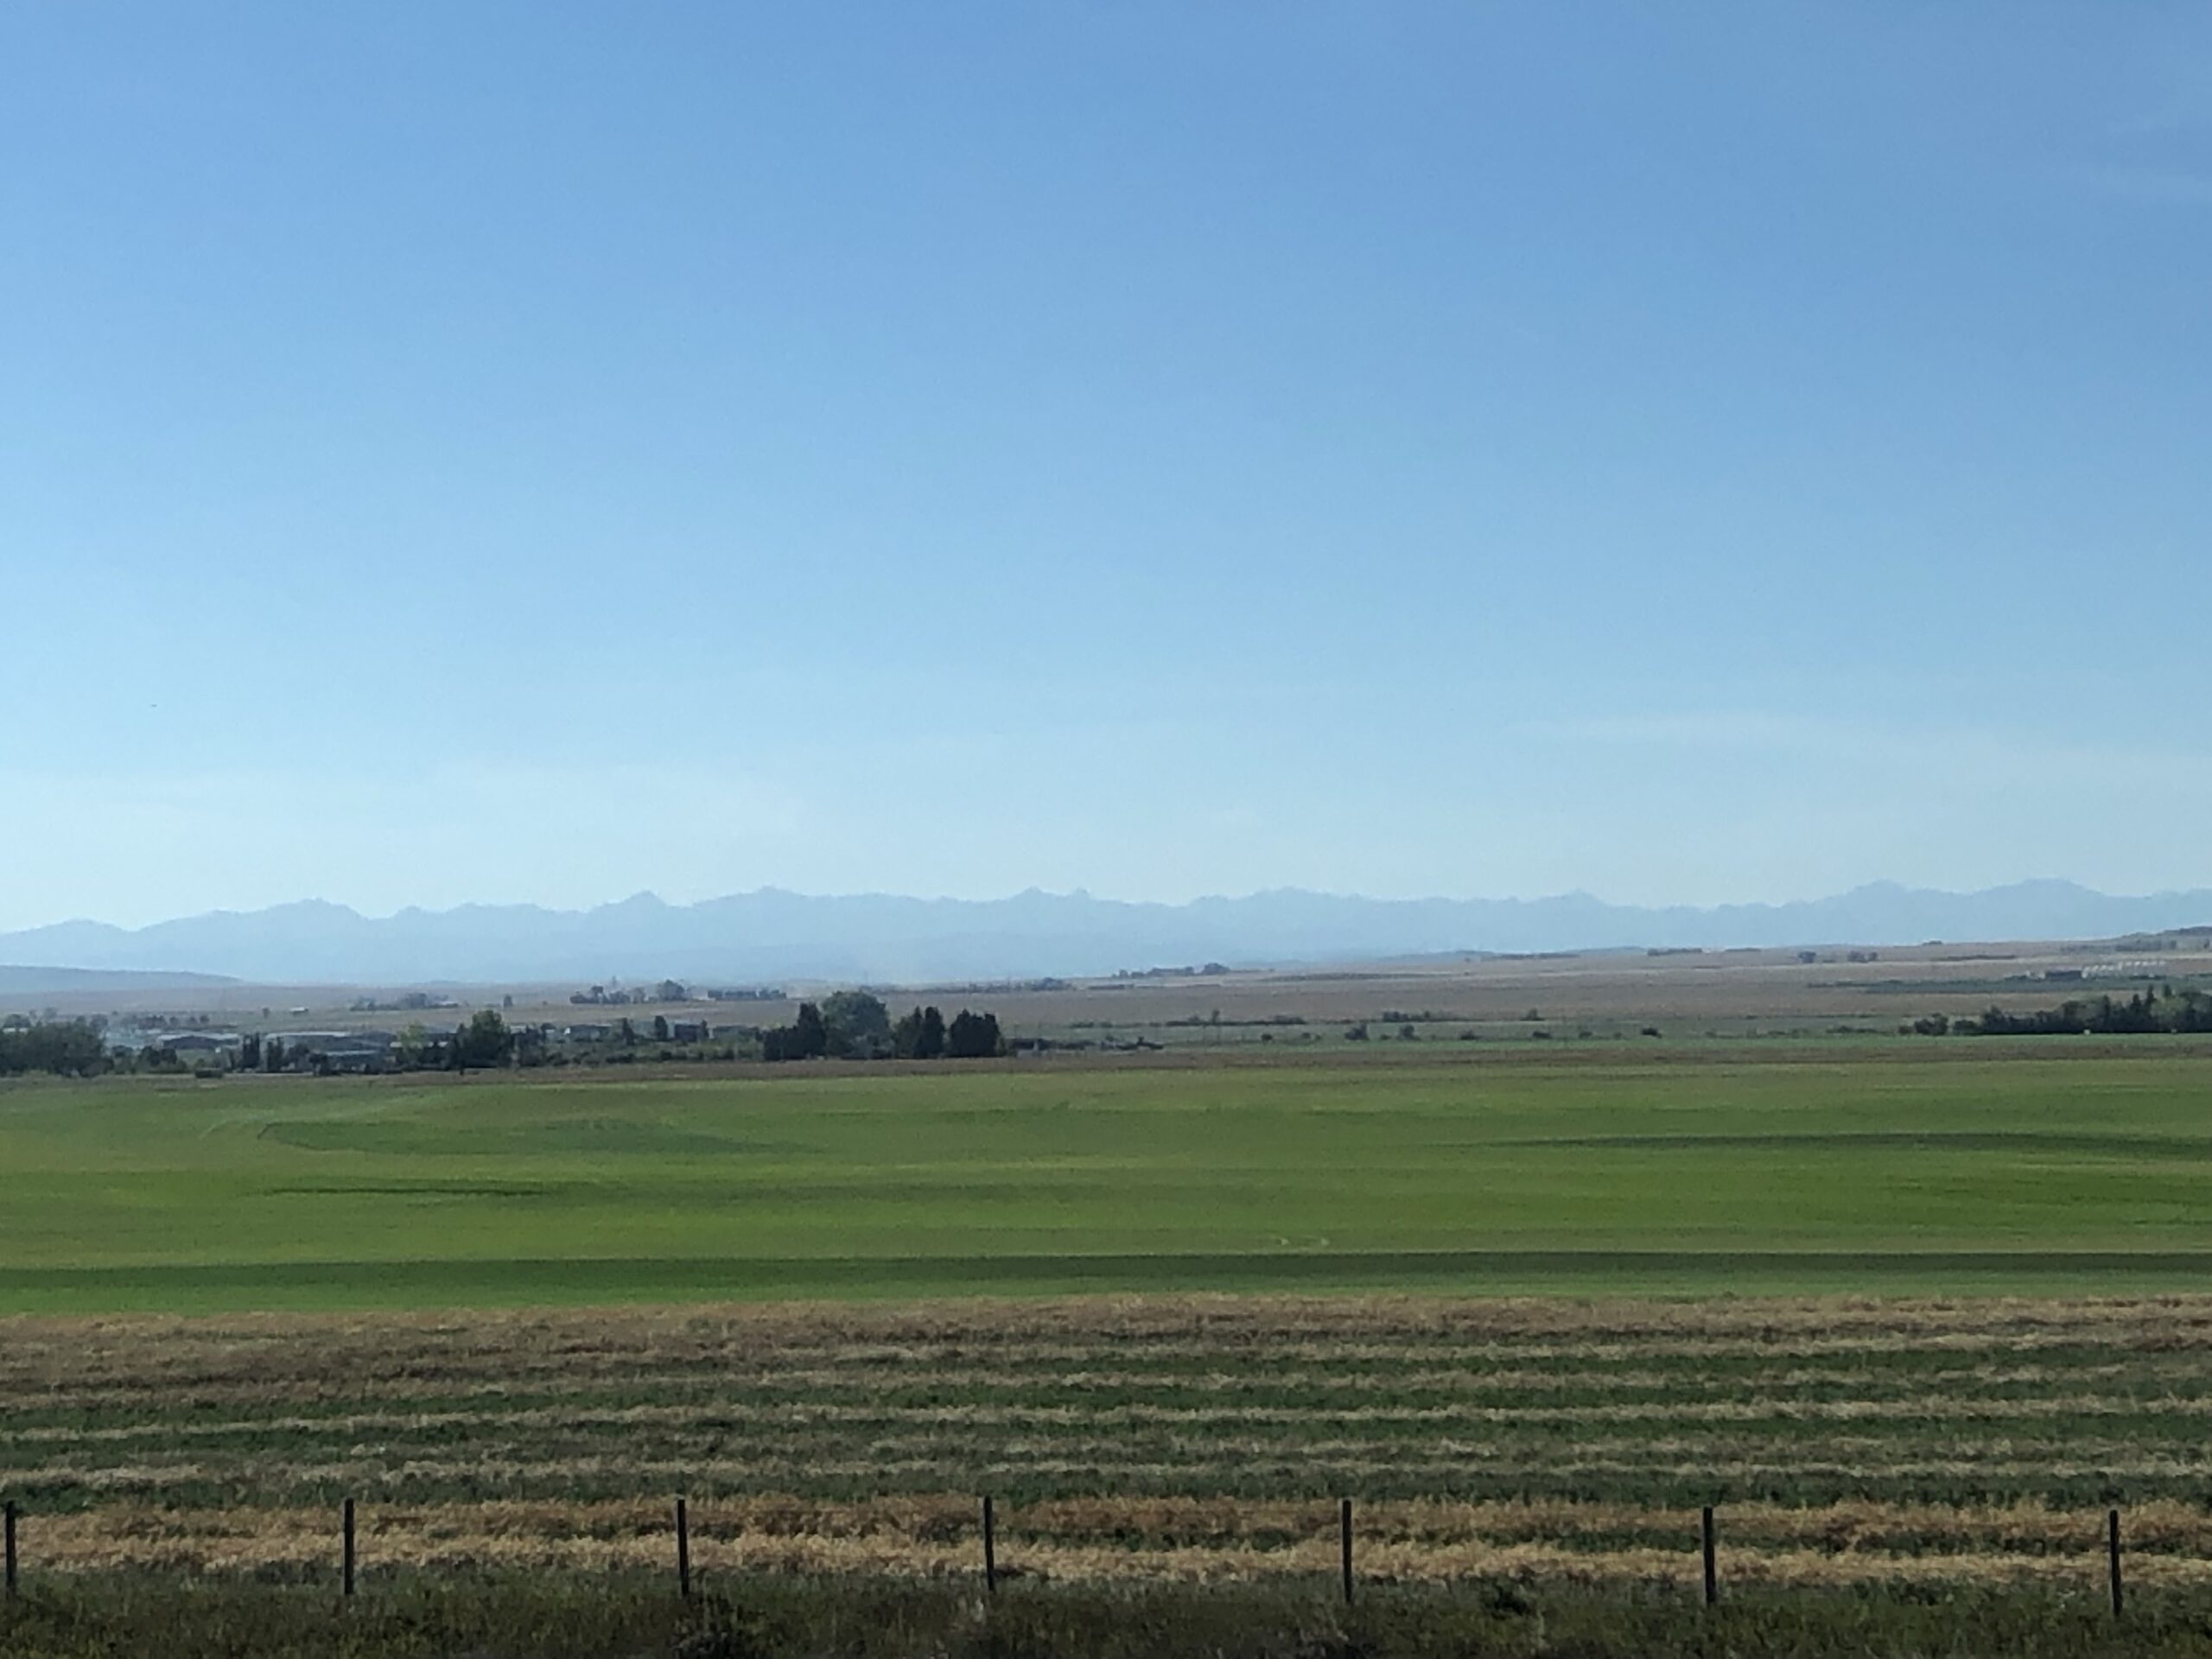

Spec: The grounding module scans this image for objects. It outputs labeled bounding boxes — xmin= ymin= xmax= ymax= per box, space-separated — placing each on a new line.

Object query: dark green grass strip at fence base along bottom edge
xmin=0 ymin=1580 xmax=2212 ymax=1659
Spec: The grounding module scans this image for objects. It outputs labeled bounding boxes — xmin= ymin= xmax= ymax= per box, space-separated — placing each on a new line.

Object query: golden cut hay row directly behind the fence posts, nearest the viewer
xmin=9 ymin=1497 xmax=2212 ymax=1586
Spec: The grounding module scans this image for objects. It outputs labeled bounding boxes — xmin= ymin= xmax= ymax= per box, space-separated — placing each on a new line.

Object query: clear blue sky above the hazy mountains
xmin=0 ymin=0 xmax=2212 ymax=927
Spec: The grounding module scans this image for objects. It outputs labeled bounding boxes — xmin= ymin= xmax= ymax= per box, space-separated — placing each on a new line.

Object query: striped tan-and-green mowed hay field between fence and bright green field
xmin=13 ymin=1299 xmax=2212 ymax=1597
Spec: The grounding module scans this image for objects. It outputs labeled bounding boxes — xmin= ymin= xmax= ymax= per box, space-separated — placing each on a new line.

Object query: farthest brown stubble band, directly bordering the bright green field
xmin=17 ymin=1296 xmax=2212 ymax=1385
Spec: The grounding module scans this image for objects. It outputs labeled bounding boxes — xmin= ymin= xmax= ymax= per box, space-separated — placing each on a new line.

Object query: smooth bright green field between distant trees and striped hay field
xmin=0 ymin=1039 xmax=2212 ymax=1312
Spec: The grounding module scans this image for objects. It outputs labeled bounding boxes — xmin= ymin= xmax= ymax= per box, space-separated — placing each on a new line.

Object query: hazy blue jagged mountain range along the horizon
xmin=0 ymin=880 xmax=2212 ymax=988
